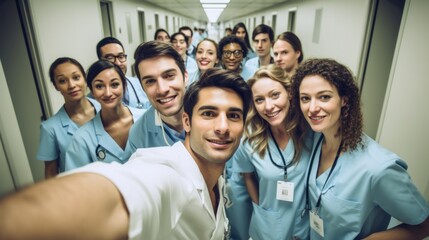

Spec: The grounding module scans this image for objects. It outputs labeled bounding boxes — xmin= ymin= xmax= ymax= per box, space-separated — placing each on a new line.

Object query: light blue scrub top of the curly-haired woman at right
xmin=309 ymin=135 xmax=429 ymax=239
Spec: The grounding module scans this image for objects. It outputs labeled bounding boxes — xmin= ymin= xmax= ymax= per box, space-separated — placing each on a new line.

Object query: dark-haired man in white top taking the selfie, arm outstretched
xmin=0 ymin=66 xmax=251 ymax=240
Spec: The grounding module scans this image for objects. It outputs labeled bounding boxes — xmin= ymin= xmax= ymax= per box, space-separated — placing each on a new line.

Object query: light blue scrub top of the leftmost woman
xmin=36 ymin=98 xmax=100 ymax=172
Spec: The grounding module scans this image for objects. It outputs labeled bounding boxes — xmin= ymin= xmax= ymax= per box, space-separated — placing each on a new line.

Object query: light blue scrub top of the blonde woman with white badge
xmin=231 ymin=137 xmax=312 ymax=240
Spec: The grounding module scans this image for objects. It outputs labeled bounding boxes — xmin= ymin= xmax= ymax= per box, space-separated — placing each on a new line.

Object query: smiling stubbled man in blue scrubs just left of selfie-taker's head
xmin=129 ymin=41 xmax=188 ymax=151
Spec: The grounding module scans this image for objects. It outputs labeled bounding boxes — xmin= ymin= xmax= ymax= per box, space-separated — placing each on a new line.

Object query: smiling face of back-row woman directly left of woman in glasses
xmin=195 ymin=40 xmax=219 ymax=72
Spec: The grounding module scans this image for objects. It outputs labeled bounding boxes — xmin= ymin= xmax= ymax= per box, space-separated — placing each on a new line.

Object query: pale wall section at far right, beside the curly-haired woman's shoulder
xmin=378 ymin=0 xmax=429 ymax=200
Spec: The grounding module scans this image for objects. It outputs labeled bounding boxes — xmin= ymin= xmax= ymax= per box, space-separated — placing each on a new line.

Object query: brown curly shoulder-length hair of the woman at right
xmin=291 ymin=58 xmax=364 ymax=151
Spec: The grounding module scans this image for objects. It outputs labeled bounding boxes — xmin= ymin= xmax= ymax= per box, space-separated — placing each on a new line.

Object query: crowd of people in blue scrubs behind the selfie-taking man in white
xmin=37 ymin=19 xmax=429 ymax=240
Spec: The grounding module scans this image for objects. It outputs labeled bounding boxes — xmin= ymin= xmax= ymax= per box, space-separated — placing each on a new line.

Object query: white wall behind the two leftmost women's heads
xmin=29 ymin=0 xmax=103 ymax=112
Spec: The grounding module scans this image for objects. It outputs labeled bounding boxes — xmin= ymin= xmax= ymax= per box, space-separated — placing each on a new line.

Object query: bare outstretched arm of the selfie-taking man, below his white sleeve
xmin=0 ymin=173 xmax=128 ymax=239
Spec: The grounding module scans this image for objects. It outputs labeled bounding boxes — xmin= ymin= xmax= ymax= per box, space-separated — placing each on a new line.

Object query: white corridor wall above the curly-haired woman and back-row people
xmin=223 ymin=0 xmax=369 ymax=73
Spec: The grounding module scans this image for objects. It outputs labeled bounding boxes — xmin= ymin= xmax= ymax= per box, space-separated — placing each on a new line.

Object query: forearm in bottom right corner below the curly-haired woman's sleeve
xmin=365 ymin=217 xmax=429 ymax=240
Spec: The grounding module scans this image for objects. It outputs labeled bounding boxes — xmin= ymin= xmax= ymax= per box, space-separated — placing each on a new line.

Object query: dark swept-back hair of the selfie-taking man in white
xmin=183 ymin=68 xmax=252 ymax=123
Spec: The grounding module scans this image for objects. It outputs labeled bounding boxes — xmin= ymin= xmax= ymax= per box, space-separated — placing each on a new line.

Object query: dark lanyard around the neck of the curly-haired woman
xmin=301 ymin=135 xmax=343 ymax=217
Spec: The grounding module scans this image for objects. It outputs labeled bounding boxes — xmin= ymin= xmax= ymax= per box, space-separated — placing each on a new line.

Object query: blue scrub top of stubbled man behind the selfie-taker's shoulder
xmin=128 ymin=107 xmax=185 ymax=152
